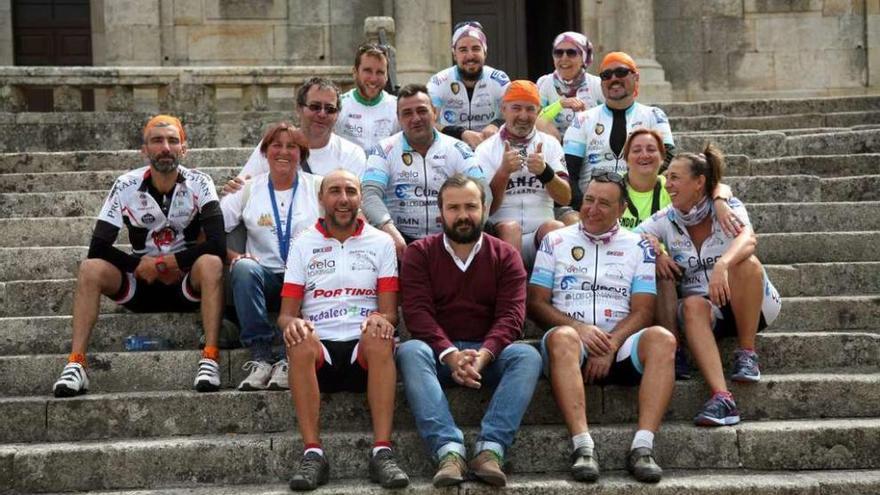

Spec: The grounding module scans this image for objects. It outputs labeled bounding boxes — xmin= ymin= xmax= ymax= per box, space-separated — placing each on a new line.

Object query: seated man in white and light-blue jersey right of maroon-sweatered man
xmin=528 ymin=170 xmax=676 ymax=483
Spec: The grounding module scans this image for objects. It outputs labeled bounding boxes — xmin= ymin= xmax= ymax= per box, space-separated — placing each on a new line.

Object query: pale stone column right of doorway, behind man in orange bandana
xmin=616 ymin=0 xmax=672 ymax=102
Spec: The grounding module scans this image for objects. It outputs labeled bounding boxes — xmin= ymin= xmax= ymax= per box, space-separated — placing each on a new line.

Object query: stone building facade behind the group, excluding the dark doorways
xmin=0 ymin=0 xmax=880 ymax=101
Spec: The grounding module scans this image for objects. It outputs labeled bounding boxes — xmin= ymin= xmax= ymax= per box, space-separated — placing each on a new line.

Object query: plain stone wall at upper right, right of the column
xmin=654 ymin=0 xmax=868 ymax=99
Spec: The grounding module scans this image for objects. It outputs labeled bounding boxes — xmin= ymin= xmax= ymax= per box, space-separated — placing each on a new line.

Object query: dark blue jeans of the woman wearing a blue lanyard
xmin=229 ymin=258 xmax=284 ymax=363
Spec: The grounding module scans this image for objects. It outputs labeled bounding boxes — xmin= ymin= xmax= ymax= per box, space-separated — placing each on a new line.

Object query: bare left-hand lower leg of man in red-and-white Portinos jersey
xmin=287 ymin=333 xmax=327 ymax=444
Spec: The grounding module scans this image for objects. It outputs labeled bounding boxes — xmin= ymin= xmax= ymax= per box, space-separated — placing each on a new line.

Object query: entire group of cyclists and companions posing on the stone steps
xmin=53 ymin=22 xmax=781 ymax=490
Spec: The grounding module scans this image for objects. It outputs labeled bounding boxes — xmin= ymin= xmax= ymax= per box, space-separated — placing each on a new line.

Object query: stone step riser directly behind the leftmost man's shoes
xmin=0 ymin=332 xmax=880 ymax=396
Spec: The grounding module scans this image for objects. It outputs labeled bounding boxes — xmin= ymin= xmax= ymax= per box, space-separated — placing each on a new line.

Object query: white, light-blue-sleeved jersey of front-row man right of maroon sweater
xmin=529 ymin=223 xmax=657 ymax=332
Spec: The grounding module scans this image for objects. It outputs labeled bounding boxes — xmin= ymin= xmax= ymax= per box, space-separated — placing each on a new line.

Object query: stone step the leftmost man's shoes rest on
xmin=0 ymin=373 xmax=880 ymax=444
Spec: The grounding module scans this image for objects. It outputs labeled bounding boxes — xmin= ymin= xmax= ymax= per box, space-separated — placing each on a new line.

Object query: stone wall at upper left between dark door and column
xmin=92 ymin=0 xmax=384 ymax=66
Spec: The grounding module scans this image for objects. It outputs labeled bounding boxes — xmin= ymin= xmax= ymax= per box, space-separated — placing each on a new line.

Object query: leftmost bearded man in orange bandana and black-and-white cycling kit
xmin=53 ymin=115 xmax=226 ymax=397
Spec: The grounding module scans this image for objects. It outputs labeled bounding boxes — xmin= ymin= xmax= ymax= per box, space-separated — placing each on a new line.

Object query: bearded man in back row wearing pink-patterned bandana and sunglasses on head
xmin=428 ymin=21 xmax=510 ymax=148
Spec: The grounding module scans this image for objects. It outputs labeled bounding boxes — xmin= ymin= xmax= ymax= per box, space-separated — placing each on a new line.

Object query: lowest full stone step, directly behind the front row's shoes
xmin=0 ymin=419 xmax=880 ymax=492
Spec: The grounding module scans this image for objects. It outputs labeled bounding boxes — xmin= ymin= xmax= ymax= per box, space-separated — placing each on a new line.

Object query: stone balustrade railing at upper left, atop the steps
xmin=0 ymin=66 xmax=352 ymax=112
